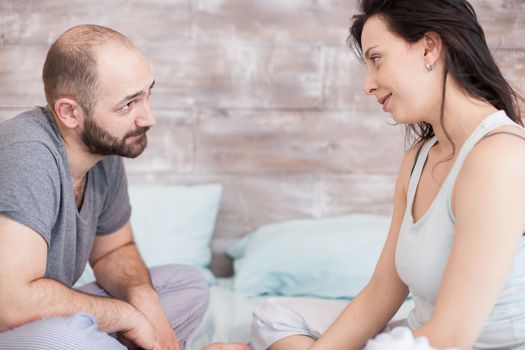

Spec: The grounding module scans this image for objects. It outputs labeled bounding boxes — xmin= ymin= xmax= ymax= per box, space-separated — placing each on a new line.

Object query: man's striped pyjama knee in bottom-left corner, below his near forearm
xmin=0 ymin=313 xmax=126 ymax=350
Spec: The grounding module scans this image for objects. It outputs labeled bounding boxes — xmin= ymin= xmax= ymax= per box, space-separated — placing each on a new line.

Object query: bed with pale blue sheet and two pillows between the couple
xmin=77 ymin=183 xmax=411 ymax=350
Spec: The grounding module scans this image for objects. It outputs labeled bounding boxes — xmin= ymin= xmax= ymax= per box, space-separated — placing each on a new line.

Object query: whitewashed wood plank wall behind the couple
xmin=0 ymin=0 xmax=525 ymax=275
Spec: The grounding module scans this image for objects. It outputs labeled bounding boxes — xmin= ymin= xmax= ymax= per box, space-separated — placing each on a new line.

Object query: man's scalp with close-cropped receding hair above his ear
xmin=42 ymin=24 xmax=136 ymax=115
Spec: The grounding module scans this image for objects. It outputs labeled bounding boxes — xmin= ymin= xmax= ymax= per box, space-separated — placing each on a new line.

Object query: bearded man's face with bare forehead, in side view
xmin=80 ymin=43 xmax=155 ymax=158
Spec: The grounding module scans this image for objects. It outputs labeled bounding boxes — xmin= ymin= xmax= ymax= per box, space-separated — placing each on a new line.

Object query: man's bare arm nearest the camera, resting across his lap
xmin=0 ymin=215 xmax=154 ymax=348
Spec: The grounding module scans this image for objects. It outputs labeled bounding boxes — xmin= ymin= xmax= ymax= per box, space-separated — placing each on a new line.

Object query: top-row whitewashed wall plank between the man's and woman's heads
xmin=193 ymin=0 xmax=354 ymax=46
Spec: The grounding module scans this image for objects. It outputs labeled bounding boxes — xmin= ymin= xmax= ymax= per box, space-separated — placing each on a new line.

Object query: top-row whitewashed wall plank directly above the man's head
xmin=0 ymin=0 xmax=192 ymax=45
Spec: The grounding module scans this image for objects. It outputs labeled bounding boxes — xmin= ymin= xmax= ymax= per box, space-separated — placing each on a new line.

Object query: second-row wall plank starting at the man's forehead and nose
xmin=143 ymin=43 xmax=322 ymax=109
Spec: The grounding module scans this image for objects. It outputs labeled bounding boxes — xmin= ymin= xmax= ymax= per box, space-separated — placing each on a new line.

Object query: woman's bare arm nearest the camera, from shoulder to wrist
xmin=415 ymin=135 xmax=525 ymax=349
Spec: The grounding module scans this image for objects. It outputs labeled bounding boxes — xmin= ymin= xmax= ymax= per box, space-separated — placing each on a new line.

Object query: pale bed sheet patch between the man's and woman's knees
xmin=185 ymin=278 xmax=413 ymax=350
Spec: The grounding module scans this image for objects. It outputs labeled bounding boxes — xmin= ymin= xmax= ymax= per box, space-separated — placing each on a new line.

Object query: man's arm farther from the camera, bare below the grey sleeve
xmin=89 ymin=221 xmax=179 ymax=349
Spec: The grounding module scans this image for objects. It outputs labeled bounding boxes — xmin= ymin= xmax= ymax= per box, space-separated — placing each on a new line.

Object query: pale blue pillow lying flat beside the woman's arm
xmin=228 ymin=214 xmax=390 ymax=298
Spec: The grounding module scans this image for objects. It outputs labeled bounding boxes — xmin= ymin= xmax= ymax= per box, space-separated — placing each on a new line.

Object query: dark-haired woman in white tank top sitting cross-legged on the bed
xmin=249 ymin=0 xmax=525 ymax=350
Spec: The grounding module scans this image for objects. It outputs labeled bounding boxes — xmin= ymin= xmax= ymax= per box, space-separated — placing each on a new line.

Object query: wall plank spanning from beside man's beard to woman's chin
xmin=195 ymin=111 xmax=403 ymax=174
